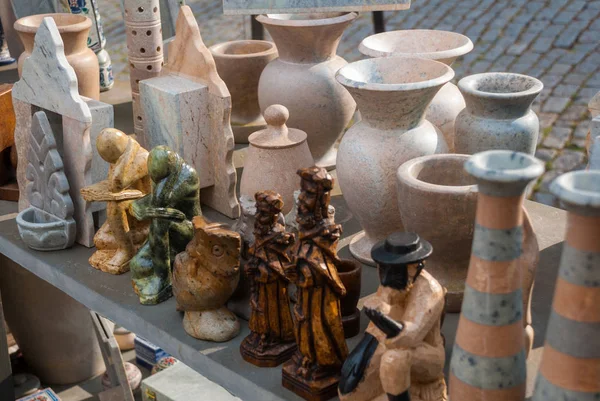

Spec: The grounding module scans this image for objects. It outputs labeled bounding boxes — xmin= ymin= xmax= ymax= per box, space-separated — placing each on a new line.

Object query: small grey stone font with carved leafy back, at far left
xmin=17 ymin=111 xmax=76 ymax=251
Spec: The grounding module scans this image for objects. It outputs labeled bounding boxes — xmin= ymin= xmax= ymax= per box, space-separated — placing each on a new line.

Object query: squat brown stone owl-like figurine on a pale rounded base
xmin=173 ymin=216 xmax=242 ymax=342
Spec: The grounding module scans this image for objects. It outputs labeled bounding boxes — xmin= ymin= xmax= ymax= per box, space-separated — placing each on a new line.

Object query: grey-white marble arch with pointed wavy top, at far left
xmin=13 ymin=17 xmax=114 ymax=247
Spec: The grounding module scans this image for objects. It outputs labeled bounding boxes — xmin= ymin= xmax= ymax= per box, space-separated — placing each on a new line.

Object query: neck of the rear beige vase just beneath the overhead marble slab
xmin=265 ymin=20 xmax=352 ymax=64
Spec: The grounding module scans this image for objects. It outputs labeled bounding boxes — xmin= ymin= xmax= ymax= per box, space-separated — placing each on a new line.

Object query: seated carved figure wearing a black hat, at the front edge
xmin=339 ymin=232 xmax=447 ymax=401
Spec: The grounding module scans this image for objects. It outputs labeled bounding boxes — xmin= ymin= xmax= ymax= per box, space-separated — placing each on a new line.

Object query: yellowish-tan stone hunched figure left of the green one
xmin=81 ymin=128 xmax=150 ymax=274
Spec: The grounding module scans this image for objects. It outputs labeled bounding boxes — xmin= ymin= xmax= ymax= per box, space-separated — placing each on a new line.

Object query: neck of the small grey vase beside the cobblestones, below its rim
xmin=463 ymin=92 xmax=537 ymax=120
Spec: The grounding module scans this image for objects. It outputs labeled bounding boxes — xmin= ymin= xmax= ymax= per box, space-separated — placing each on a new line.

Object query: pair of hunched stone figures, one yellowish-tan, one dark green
xmin=81 ymin=128 xmax=201 ymax=304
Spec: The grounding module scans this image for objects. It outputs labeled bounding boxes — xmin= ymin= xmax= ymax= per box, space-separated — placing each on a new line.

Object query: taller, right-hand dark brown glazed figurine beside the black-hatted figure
xmin=283 ymin=167 xmax=348 ymax=401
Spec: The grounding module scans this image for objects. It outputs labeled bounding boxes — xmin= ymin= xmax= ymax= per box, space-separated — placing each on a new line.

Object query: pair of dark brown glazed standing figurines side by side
xmin=241 ymin=167 xmax=348 ymax=398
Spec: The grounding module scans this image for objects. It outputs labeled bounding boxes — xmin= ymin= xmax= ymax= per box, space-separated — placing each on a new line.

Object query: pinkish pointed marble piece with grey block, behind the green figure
xmin=140 ymin=6 xmax=240 ymax=218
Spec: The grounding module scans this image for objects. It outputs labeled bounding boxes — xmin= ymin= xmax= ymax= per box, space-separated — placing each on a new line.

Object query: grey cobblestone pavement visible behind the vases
xmin=100 ymin=0 xmax=600 ymax=206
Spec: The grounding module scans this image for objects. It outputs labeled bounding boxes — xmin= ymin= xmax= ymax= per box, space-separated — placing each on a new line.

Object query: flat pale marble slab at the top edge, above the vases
xmin=223 ymin=0 xmax=410 ymax=15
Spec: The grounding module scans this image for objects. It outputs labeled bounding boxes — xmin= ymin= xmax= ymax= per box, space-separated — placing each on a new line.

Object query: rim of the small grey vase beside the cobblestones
xmin=458 ymin=72 xmax=544 ymax=100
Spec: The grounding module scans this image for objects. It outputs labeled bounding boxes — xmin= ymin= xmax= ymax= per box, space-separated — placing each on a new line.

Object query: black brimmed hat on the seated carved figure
xmin=371 ymin=232 xmax=433 ymax=266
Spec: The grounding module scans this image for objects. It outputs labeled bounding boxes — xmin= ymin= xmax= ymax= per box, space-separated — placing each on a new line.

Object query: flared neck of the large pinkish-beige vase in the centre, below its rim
xmin=346 ymin=85 xmax=441 ymax=131
